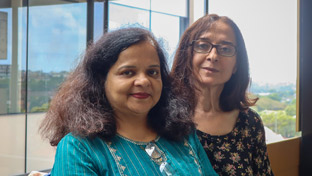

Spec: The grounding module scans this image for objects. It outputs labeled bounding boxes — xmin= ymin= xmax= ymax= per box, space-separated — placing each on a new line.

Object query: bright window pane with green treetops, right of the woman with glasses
xmin=209 ymin=0 xmax=300 ymax=142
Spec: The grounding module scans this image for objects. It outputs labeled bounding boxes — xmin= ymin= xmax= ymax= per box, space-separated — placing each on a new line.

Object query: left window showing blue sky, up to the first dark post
xmin=0 ymin=0 xmax=86 ymax=175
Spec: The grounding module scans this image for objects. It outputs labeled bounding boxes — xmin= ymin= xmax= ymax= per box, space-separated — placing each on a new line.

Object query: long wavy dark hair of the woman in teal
xmin=40 ymin=28 xmax=194 ymax=146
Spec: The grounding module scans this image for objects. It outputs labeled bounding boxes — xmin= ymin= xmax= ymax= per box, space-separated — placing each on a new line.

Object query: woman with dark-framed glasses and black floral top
xmin=171 ymin=14 xmax=273 ymax=175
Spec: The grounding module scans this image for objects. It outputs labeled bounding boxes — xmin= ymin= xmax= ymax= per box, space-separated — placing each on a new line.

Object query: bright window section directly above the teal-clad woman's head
xmin=109 ymin=1 xmax=188 ymax=66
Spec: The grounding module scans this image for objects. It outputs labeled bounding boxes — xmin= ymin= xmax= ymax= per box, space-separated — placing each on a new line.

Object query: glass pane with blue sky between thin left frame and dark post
xmin=27 ymin=0 xmax=87 ymax=172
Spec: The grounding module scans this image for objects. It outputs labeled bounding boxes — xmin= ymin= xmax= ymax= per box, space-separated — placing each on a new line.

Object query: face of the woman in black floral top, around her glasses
xmin=192 ymin=21 xmax=236 ymax=88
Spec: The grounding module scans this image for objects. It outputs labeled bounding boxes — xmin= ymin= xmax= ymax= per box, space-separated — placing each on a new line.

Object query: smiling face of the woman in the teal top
xmin=105 ymin=42 xmax=162 ymax=117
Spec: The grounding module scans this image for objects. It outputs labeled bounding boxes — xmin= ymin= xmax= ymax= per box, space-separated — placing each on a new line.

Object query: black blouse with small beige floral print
xmin=197 ymin=109 xmax=273 ymax=176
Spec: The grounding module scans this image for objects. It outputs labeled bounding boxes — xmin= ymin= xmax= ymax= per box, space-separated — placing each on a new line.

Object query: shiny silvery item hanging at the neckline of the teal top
xmin=145 ymin=142 xmax=173 ymax=176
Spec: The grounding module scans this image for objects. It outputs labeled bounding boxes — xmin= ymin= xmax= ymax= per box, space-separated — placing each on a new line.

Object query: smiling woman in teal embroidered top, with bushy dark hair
xmin=41 ymin=28 xmax=217 ymax=176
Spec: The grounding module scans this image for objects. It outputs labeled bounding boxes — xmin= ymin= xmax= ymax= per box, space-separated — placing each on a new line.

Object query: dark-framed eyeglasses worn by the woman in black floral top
xmin=190 ymin=39 xmax=236 ymax=57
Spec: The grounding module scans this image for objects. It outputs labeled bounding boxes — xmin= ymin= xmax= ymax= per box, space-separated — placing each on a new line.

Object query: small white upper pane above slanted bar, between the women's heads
xmin=151 ymin=0 xmax=187 ymax=17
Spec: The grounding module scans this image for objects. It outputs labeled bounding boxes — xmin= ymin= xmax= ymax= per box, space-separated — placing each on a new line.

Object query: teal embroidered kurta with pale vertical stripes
xmin=51 ymin=133 xmax=217 ymax=176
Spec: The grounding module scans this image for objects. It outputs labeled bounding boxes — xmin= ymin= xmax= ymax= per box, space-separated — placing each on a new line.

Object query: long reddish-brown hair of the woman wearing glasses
xmin=170 ymin=14 xmax=258 ymax=113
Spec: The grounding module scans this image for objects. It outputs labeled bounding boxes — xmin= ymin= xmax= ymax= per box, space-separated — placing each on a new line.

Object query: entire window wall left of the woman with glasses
xmin=0 ymin=0 xmax=188 ymax=175
